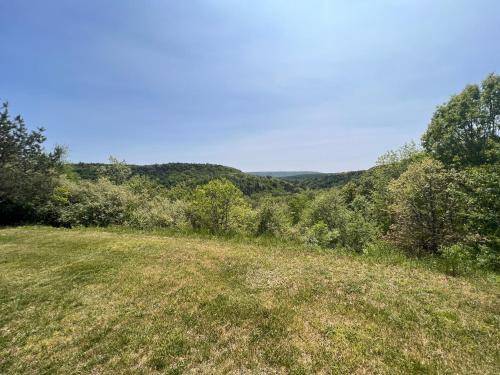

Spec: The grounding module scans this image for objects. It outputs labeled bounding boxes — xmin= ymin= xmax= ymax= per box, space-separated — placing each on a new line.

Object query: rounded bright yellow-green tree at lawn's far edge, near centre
xmin=191 ymin=179 xmax=247 ymax=233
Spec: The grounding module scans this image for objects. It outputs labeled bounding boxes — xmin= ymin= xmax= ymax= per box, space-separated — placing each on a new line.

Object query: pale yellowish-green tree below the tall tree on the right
xmin=389 ymin=157 xmax=460 ymax=254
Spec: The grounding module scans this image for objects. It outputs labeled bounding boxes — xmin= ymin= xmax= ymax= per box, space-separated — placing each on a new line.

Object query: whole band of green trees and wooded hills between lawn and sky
xmin=0 ymin=74 xmax=500 ymax=275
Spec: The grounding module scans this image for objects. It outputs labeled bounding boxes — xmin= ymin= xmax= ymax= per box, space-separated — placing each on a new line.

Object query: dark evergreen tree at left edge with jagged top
xmin=0 ymin=103 xmax=64 ymax=224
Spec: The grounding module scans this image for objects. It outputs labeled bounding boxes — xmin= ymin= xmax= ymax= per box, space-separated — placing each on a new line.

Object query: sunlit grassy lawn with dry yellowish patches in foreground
xmin=0 ymin=227 xmax=500 ymax=374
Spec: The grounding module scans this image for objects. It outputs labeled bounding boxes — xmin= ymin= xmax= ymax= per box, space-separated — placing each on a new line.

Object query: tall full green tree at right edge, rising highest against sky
xmin=422 ymin=74 xmax=500 ymax=166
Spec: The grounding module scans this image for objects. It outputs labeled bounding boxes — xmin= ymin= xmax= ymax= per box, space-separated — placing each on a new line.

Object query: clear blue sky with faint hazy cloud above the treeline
xmin=0 ymin=0 xmax=500 ymax=172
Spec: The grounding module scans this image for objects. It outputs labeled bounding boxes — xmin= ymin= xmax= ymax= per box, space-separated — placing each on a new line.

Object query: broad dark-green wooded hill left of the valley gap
xmin=72 ymin=163 xmax=300 ymax=195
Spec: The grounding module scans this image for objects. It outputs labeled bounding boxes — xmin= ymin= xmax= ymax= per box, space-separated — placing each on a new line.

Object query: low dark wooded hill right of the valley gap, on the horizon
xmin=282 ymin=171 xmax=365 ymax=189
